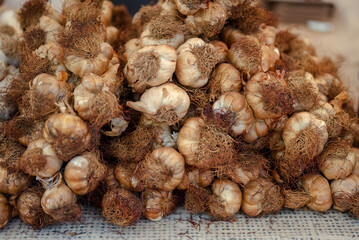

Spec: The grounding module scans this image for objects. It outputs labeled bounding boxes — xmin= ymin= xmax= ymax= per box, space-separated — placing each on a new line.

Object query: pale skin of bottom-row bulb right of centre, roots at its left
xmin=210 ymin=179 xmax=242 ymax=219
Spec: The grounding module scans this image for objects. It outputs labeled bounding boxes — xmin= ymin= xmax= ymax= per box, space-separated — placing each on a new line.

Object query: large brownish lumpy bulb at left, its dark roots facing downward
xmin=43 ymin=113 xmax=91 ymax=161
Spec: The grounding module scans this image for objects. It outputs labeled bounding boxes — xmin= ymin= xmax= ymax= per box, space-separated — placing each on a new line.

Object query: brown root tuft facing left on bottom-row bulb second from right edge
xmin=282 ymin=189 xmax=312 ymax=210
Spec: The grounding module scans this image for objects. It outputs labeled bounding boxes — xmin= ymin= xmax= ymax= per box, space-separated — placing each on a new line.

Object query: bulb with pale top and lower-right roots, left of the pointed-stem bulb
xmin=74 ymin=73 xmax=122 ymax=127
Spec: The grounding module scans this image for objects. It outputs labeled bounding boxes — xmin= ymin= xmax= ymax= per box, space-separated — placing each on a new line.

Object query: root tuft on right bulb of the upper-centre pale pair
xmin=192 ymin=45 xmax=218 ymax=77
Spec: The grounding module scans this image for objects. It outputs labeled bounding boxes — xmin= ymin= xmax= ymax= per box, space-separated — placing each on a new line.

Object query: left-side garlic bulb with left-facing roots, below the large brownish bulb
xmin=20 ymin=138 xmax=63 ymax=178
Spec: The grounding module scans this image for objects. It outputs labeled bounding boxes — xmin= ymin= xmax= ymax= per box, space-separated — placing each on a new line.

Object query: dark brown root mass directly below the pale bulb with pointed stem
xmin=110 ymin=125 xmax=156 ymax=162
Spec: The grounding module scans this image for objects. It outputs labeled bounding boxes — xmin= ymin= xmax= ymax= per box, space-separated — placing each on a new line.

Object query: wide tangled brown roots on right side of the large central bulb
xmin=194 ymin=125 xmax=235 ymax=169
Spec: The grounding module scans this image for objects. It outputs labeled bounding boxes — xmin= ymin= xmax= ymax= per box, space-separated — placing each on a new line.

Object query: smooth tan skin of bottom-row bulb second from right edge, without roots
xmin=302 ymin=174 xmax=332 ymax=212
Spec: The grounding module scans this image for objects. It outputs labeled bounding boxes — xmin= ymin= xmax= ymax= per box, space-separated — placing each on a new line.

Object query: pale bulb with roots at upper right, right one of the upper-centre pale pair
xmin=175 ymin=38 xmax=218 ymax=88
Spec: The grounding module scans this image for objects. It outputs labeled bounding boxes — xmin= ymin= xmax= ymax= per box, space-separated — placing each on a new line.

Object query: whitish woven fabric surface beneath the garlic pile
xmin=0 ymin=207 xmax=359 ymax=240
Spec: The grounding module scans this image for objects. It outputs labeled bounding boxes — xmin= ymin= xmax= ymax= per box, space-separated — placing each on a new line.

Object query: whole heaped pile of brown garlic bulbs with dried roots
xmin=0 ymin=0 xmax=359 ymax=228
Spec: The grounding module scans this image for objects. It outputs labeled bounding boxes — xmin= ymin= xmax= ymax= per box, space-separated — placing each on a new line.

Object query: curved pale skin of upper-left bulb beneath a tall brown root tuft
xmin=64 ymin=42 xmax=113 ymax=77
